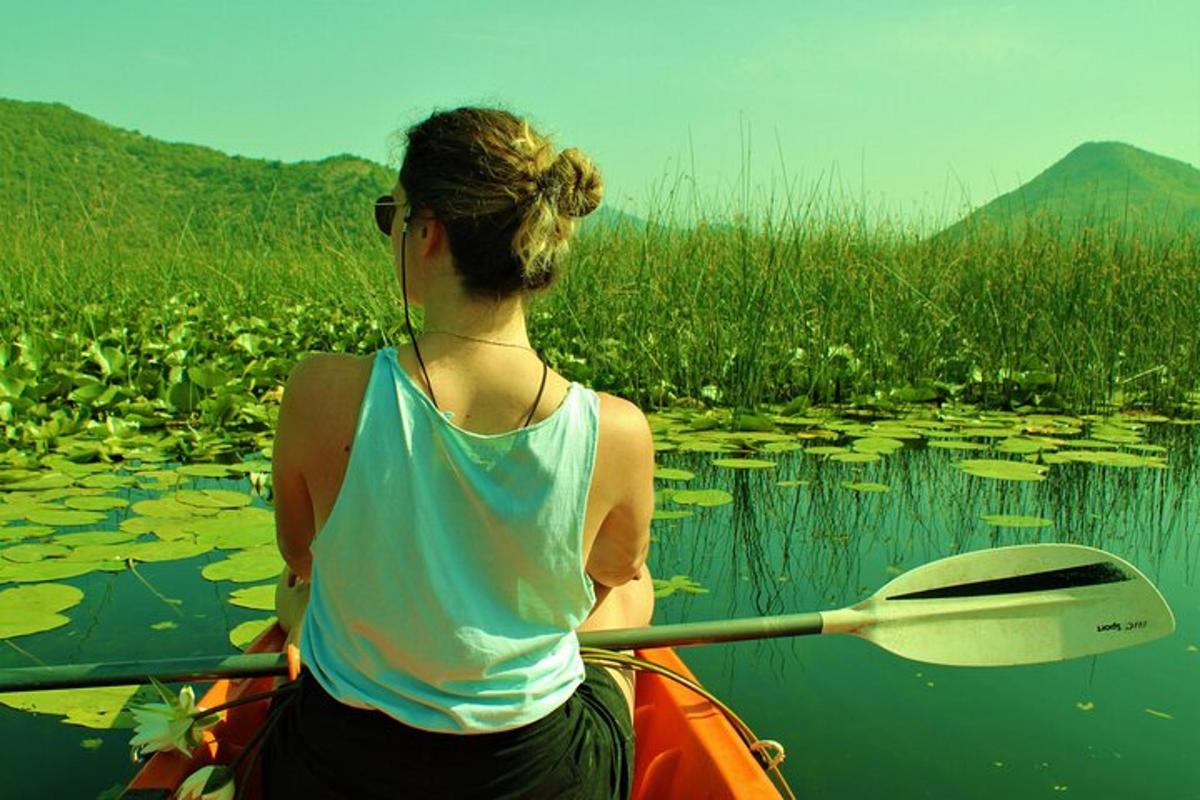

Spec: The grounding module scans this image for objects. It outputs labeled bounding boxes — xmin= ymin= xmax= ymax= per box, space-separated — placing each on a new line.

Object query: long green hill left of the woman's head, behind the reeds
xmin=0 ymin=98 xmax=636 ymax=240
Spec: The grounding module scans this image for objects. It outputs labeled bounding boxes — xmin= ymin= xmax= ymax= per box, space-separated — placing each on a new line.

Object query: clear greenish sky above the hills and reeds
xmin=0 ymin=0 xmax=1200 ymax=225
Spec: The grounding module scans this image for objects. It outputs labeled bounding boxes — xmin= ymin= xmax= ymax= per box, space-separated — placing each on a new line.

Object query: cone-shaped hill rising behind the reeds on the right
xmin=941 ymin=142 xmax=1200 ymax=235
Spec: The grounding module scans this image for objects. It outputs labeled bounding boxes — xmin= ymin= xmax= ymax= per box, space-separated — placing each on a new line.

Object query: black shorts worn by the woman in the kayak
xmin=263 ymin=664 xmax=634 ymax=800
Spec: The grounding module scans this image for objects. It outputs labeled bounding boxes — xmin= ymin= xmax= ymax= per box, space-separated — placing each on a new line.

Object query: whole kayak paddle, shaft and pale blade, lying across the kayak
xmin=0 ymin=545 xmax=1175 ymax=692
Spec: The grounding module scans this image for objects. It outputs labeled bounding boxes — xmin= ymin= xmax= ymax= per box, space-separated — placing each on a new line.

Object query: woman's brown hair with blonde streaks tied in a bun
xmin=400 ymin=108 xmax=604 ymax=297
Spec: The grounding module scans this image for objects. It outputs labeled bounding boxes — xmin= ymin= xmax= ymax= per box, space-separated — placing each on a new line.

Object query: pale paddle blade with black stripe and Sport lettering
xmin=830 ymin=545 xmax=1175 ymax=667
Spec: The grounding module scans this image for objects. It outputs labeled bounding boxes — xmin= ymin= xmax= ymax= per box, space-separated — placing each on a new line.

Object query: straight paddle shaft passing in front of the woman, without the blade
xmin=0 ymin=612 xmax=822 ymax=692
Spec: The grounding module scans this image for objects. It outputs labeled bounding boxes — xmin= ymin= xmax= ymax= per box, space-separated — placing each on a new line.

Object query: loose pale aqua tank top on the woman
xmin=301 ymin=349 xmax=598 ymax=733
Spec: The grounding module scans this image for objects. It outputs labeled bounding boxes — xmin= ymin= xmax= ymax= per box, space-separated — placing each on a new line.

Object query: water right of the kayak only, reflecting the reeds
xmin=652 ymin=426 xmax=1200 ymax=798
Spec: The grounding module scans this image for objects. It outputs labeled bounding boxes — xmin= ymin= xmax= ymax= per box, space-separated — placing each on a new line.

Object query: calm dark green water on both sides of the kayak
xmin=0 ymin=432 xmax=1200 ymax=800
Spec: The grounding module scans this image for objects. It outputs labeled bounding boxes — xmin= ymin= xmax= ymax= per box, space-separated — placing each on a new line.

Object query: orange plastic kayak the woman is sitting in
xmin=124 ymin=626 xmax=781 ymax=800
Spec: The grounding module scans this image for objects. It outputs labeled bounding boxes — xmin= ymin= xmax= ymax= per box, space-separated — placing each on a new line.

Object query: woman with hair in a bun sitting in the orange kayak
xmin=264 ymin=108 xmax=654 ymax=799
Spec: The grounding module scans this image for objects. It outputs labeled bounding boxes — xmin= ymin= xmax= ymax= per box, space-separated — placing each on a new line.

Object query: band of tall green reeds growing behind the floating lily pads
xmin=0 ymin=200 xmax=1200 ymax=424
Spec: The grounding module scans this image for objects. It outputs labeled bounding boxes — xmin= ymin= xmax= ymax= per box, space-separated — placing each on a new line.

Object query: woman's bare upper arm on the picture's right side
xmin=587 ymin=395 xmax=654 ymax=596
